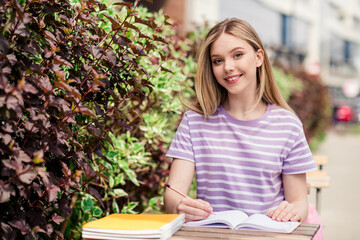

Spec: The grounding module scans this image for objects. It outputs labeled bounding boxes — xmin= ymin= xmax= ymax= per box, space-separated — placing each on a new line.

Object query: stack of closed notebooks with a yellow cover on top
xmin=82 ymin=214 xmax=185 ymax=240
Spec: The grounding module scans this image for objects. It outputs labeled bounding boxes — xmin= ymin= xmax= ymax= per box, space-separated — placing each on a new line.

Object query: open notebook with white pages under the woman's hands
xmin=184 ymin=210 xmax=300 ymax=233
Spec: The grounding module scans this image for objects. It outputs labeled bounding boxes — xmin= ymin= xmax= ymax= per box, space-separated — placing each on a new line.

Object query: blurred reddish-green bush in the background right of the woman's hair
xmin=273 ymin=57 xmax=332 ymax=151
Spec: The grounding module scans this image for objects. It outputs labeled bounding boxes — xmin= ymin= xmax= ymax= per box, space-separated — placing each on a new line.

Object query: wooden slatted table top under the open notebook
xmin=169 ymin=223 xmax=320 ymax=240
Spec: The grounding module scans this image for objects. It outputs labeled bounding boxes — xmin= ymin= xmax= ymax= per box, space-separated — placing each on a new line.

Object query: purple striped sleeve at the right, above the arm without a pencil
xmin=283 ymin=130 xmax=316 ymax=174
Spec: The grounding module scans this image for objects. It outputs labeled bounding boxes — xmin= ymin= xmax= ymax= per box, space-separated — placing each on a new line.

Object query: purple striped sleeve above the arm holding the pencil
xmin=166 ymin=114 xmax=195 ymax=162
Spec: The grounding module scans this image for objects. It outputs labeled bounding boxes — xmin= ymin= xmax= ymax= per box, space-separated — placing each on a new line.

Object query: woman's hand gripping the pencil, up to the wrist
xmin=177 ymin=197 xmax=213 ymax=222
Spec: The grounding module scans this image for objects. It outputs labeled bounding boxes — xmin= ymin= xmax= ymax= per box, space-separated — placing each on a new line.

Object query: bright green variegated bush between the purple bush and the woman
xmin=65 ymin=7 xmax=196 ymax=238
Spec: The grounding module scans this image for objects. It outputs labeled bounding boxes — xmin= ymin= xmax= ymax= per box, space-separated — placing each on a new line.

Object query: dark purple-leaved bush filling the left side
xmin=0 ymin=0 xmax=186 ymax=239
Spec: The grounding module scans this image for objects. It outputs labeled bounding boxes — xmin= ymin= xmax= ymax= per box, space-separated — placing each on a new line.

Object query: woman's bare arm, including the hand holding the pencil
xmin=164 ymin=159 xmax=212 ymax=221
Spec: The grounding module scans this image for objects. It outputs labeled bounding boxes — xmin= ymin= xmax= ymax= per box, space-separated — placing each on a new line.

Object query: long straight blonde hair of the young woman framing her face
xmin=183 ymin=18 xmax=293 ymax=117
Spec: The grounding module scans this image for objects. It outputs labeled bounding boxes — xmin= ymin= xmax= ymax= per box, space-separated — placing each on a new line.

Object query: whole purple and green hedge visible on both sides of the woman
xmin=0 ymin=0 xmax=328 ymax=239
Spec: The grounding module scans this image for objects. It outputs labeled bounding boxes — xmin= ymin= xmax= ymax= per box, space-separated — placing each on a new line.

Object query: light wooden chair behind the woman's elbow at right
xmin=306 ymin=155 xmax=330 ymax=213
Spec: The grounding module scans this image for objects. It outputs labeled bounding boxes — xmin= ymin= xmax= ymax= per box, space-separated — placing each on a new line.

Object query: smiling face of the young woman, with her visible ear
xmin=210 ymin=33 xmax=264 ymax=98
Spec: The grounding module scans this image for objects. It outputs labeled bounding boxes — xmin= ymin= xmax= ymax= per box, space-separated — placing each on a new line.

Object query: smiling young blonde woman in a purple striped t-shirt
xmin=165 ymin=19 xmax=316 ymax=221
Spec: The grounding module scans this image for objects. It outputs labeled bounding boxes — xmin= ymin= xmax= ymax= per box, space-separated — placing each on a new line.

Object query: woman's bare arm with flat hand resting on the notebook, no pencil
xmin=267 ymin=173 xmax=308 ymax=222
